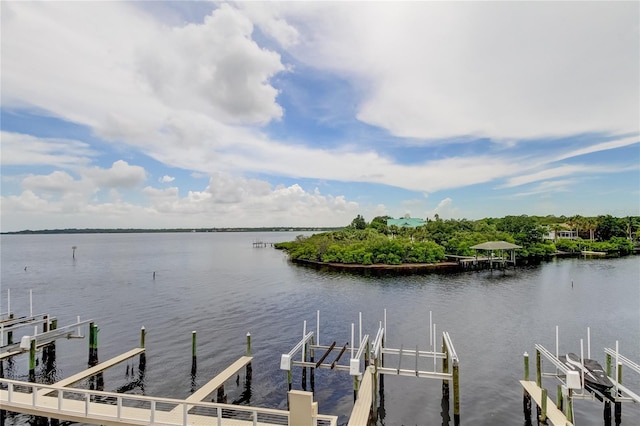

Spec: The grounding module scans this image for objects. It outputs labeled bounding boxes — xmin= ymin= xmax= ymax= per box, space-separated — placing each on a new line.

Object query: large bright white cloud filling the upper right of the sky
xmin=249 ymin=2 xmax=640 ymax=140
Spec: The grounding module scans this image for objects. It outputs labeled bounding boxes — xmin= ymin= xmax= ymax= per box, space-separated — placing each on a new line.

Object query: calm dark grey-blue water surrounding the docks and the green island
xmin=0 ymin=233 xmax=640 ymax=426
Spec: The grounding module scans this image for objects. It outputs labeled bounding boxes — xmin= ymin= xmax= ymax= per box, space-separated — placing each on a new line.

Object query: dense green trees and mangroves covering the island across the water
xmin=275 ymin=215 xmax=640 ymax=265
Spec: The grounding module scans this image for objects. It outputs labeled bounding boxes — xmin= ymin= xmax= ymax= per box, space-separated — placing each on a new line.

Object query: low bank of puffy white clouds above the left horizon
xmin=0 ymin=171 xmax=360 ymax=229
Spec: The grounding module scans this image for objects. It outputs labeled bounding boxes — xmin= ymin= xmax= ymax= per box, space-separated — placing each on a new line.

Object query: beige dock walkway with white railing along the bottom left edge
xmin=0 ymin=378 xmax=337 ymax=426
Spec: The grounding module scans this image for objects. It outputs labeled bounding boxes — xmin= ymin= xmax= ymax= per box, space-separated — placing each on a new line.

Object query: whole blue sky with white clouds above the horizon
xmin=0 ymin=1 xmax=640 ymax=232
